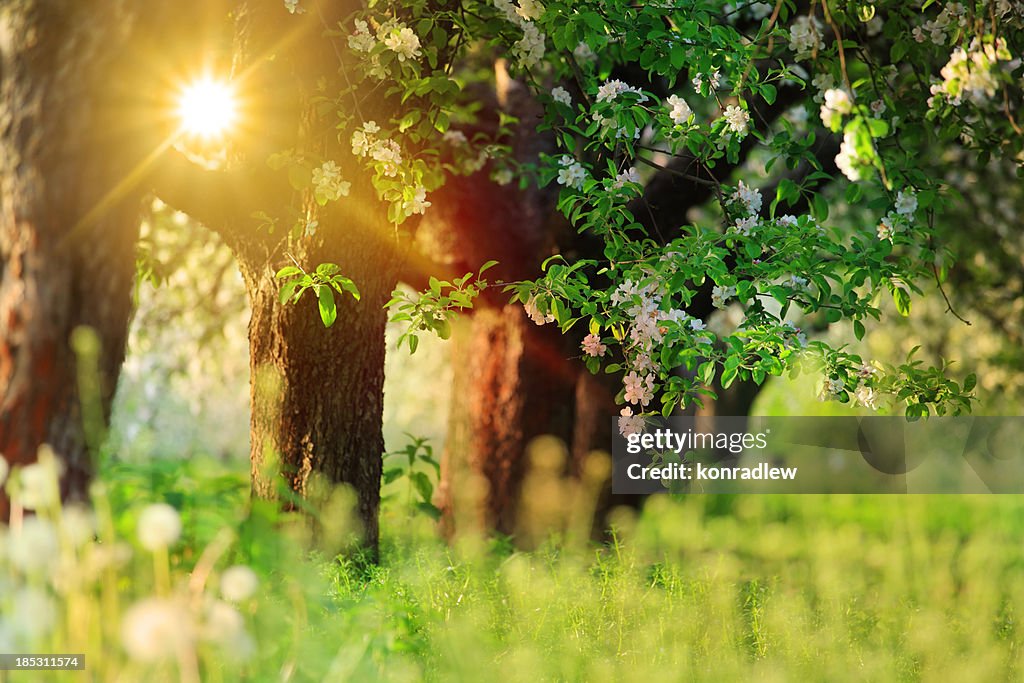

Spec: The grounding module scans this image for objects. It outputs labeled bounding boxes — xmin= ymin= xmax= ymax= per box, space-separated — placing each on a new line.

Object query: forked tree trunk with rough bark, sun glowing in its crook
xmin=141 ymin=0 xmax=401 ymax=554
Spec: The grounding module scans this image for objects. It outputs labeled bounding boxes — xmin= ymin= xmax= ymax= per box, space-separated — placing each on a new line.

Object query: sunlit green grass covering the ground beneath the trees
xmin=0 ymin=450 xmax=1024 ymax=682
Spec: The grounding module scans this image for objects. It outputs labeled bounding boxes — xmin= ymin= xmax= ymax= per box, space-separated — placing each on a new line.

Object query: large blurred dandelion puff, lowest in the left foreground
xmin=121 ymin=598 xmax=196 ymax=661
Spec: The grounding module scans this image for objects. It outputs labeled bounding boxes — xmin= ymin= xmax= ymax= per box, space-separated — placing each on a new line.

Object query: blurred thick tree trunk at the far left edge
xmin=0 ymin=0 xmax=140 ymax=519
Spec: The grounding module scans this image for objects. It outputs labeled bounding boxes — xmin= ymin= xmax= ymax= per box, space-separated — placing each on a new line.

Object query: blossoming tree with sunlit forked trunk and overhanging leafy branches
xmin=4 ymin=0 xmax=1022 ymax=546
